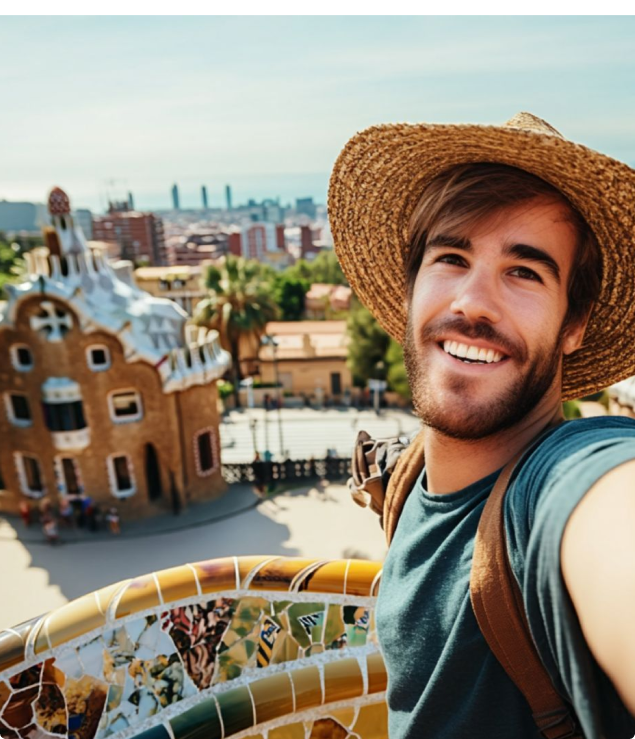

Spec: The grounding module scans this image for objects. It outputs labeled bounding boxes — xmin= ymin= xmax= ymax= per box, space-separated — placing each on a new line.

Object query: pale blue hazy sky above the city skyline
xmin=0 ymin=15 xmax=635 ymax=209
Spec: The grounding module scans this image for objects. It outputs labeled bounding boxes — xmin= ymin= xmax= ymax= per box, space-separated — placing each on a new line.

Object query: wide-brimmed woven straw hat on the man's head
xmin=328 ymin=113 xmax=635 ymax=400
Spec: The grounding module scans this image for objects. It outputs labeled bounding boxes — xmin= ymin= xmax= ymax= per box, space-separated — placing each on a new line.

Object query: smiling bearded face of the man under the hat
xmin=404 ymin=199 xmax=584 ymax=439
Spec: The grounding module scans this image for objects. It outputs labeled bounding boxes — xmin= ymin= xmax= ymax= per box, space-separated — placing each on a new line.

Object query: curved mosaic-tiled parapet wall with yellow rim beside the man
xmin=0 ymin=557 xmax=387 ymax=739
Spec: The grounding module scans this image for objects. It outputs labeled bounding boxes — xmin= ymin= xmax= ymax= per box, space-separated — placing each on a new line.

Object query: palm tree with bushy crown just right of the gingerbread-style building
xmin=193 ymin=255 xmax=278 ymax=408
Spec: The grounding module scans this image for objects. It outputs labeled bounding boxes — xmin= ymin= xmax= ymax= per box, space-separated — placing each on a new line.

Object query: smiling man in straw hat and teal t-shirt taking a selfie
xmin=329 ymin=113 xmax=635 ymax=739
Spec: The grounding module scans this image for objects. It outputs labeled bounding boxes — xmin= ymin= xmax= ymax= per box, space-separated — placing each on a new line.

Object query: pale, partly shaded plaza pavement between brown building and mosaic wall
xmin=0 ymin=485 xmax=385 ymax=628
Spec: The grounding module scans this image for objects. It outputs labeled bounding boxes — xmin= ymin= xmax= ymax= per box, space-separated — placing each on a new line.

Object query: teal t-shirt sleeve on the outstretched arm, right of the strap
xmin=505 ymin=417 xmax=635 ymax=739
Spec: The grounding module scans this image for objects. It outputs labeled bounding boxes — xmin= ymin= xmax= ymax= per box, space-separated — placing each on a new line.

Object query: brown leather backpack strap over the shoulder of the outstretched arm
xmin=470 ymin=422 xmax=582 ymax=739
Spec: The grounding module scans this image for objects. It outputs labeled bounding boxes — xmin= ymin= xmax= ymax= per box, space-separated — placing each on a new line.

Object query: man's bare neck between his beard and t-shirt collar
xmin=424 ymin=396 xmax=563 ymax=495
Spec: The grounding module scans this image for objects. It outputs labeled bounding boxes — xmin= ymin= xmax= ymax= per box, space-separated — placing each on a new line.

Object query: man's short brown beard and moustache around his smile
xmin=403 ymin=310 xmax=564 ymax=441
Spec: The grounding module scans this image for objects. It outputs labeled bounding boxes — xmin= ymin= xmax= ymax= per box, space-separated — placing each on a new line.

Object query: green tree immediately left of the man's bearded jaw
xmin=346 ymin=298 xmax=390 ymax=387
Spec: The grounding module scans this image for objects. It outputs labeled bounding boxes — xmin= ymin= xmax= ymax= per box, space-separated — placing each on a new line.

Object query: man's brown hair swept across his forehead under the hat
xmin=405 ymin=162 xmax=602 ymax=336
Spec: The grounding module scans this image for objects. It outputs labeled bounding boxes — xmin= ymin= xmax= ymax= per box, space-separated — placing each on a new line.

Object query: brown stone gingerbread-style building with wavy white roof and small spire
xmin=0 ymin=188 xmax=230 ymax=517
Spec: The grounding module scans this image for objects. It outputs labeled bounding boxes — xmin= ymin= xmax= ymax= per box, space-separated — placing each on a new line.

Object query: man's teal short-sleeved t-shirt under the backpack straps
xmin=376 ymin=416 xmax=635 ymax=739
